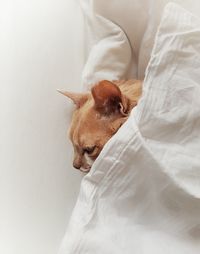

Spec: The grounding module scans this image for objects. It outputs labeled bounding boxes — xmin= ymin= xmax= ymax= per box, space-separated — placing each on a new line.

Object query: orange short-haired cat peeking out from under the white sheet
xmin=58 ymin=80 xmax=142 ymax=172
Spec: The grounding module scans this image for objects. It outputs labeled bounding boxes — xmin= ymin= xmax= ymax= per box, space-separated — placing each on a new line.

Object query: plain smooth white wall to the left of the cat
xmin=0 ymin=0 xmax=84 ymax=254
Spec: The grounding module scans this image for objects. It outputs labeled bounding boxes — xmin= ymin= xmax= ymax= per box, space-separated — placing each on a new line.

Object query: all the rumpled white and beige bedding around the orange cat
xmin=59 ymin=0 xmax=200 ymax=254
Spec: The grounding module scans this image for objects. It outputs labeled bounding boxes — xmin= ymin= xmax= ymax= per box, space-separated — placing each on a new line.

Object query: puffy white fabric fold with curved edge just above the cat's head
xmin=80 ymin=0 xmax=136 ymax=89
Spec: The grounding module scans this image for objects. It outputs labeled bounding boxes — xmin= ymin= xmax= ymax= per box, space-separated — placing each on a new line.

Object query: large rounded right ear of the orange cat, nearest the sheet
xmin=91 ymin=80 xmax=128 ymax=116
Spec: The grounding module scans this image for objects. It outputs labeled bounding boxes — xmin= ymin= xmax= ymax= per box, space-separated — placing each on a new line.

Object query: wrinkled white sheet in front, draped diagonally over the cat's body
xmin=59 ymin=4 xmax=200 ymax=254
